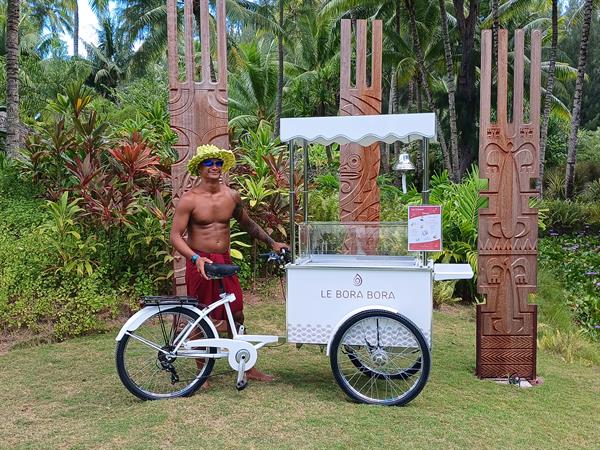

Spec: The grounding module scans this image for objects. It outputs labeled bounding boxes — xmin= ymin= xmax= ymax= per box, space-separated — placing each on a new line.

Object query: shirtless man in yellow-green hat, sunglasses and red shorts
xmin=171 ymin=145 xmax=288 ymax=381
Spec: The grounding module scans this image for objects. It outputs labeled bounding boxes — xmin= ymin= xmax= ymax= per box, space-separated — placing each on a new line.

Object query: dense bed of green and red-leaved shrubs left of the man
xmin=0 ymin=82 xmax=174 ymax=339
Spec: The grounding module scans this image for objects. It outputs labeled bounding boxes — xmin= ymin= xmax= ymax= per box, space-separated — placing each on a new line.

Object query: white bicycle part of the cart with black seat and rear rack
xmin=116 ymin=253 xmax=286 ymax=400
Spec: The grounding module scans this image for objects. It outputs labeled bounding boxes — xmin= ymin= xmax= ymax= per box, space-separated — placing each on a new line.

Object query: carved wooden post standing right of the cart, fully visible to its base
xmin=477 ymin=30 xmax=541 ymax=379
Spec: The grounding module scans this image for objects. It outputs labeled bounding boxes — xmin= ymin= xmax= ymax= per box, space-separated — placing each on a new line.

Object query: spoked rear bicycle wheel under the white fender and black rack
xmin=116 ymin=306 xmax=216 ymax=400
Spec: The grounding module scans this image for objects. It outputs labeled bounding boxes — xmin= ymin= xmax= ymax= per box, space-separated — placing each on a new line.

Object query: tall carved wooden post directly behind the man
xmin=167 ymin=0 xmax=229 ymax=295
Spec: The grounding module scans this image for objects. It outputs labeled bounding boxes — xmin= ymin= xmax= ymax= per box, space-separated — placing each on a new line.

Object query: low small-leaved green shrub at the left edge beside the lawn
xmin=0 ymin=174 xmax=123 ymax=339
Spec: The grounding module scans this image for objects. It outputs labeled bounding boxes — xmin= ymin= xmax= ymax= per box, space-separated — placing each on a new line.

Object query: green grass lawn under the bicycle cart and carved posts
xmin=0 ymin=296 xmax=600 ymax=449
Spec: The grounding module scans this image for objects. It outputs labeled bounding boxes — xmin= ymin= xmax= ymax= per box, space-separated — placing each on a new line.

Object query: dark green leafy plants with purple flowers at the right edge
xmin=539 ymin=235 xmax=600 ymax=339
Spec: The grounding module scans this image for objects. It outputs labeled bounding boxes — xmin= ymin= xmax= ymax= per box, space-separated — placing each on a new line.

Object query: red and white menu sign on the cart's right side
xmin=408 ymin=205 xmax=442 ymax=252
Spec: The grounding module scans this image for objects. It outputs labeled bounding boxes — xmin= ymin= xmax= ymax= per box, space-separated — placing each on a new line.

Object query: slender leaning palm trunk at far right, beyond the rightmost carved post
xmin=565 ymin=0 xmax=594 ymax=200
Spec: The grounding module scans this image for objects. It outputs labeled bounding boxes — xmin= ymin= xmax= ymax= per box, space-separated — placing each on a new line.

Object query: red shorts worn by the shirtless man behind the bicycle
xmin=185 ymin=250 xmax=244 ymax=320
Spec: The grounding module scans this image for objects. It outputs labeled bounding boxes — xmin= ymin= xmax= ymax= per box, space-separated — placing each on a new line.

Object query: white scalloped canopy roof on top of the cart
xmin=280 ymin=113 xmax=437 ymax=147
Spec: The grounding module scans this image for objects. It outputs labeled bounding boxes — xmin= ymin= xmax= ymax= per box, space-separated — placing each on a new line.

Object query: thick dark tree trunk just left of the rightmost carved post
xmin=454 ymin=0 xmax=479 ymax=177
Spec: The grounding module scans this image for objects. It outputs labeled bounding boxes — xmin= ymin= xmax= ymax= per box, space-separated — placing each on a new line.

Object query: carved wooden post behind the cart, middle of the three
xmin=340 ymin=19 xmax=382 ymax=254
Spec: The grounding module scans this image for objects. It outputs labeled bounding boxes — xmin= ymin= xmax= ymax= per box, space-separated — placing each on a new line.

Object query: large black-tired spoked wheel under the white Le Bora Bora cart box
xmin=330 ymin=310 xmax=431 ymax=405
